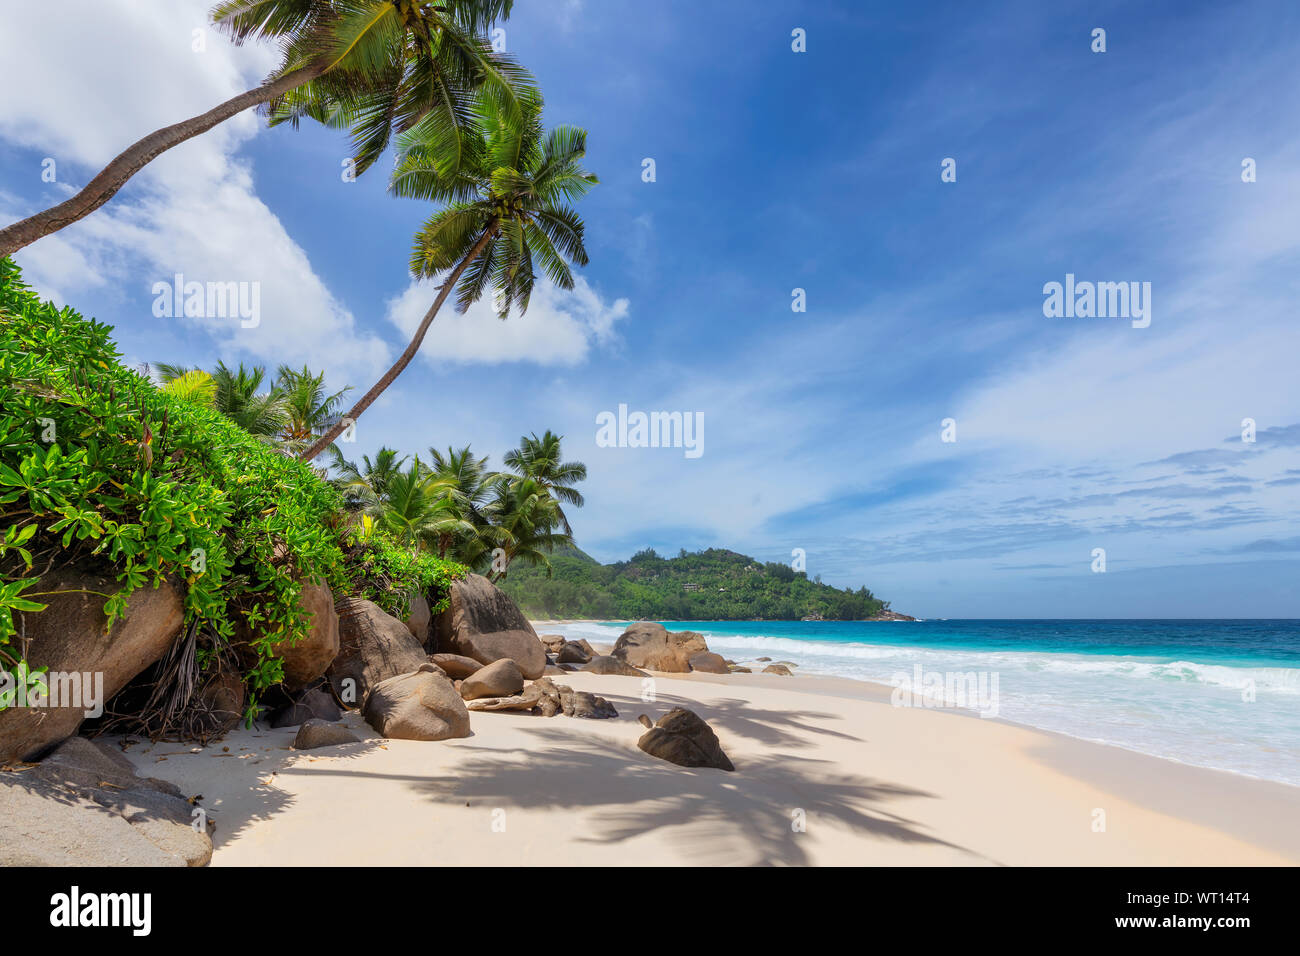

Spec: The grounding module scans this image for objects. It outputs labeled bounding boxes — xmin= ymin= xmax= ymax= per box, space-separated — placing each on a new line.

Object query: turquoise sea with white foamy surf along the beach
xmin=547 ymin=620 xmax=1300 ymax=786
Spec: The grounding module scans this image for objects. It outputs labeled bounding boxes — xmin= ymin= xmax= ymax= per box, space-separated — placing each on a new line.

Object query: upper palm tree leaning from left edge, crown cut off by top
xmin=0 ymin=0 xmax=532 ymax=259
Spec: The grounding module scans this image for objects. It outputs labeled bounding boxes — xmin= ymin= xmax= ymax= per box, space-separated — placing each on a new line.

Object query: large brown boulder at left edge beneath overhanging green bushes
xmin=0 ymin=570 xmax=185 ymax=763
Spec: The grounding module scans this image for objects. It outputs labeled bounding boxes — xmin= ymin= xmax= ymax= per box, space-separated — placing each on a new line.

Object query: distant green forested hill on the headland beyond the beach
xmin=499 ymin=548 xmax=889 ymax=620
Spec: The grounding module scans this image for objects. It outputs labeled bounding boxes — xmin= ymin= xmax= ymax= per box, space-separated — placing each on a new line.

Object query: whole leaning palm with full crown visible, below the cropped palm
xmin=302 ymin=94 xmax=597 ymax=462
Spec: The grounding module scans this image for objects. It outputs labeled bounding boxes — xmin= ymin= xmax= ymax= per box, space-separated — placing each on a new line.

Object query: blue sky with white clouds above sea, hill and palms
xmin=0 ymin=0 xmax=1300 ymax=617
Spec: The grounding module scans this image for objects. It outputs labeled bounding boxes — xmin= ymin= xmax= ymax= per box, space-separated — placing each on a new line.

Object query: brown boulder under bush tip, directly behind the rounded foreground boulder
xmin=325 ymin=598 xmax=429 ymax=706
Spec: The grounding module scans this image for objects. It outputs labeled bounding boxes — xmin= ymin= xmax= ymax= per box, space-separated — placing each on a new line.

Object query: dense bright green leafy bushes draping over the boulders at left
xmin=0 ymin=259 xmax=463 ymax=714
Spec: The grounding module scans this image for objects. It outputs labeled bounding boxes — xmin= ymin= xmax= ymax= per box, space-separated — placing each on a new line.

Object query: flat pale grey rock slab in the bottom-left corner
xmin=0 ymin=737 xmax=212 ymax=866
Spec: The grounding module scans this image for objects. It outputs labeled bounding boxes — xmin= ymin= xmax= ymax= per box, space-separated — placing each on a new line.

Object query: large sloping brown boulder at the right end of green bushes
xmin=434 ymin=575 xmax=546 ymax=680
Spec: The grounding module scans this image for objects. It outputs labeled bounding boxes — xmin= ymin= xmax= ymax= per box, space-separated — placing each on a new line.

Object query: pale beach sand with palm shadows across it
xmin=116 ymin=642 xmax=1300 ymax=866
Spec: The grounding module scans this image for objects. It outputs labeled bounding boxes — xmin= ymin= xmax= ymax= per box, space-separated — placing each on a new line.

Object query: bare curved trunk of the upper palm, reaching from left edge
xmin=0 ymin=66 xmax=325 ymax=259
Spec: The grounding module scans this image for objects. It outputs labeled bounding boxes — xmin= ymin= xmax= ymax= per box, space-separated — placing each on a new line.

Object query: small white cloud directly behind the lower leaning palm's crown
xmin=389 ymin=277 xmax=628 ymax=365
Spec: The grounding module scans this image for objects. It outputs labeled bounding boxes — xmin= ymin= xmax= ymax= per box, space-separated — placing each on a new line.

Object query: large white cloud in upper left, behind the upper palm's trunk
xmin=0 ymin=0 xmax=389 ymax=378
